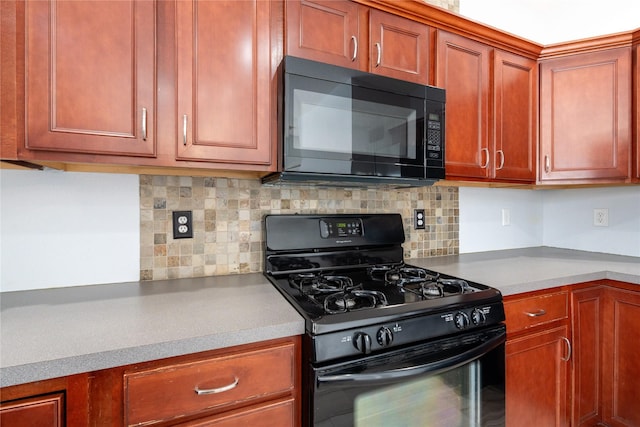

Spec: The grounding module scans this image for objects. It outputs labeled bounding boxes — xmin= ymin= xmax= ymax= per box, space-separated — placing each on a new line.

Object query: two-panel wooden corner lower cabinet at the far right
xmin=571 ymin=282 xmax=640 ymax=427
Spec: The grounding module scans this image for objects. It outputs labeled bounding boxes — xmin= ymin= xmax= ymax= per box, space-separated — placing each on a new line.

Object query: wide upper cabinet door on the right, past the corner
xmin=539 ymin=48 xmax=631 ymax=182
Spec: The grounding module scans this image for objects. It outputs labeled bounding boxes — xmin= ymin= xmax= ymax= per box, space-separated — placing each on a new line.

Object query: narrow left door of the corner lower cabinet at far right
xmin=571 ymin=287 xmax=604 ymax=427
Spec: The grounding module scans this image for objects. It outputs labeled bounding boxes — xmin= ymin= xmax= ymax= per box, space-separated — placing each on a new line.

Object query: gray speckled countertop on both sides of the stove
xmin=0 ymin=247 xmax=640 ymax=387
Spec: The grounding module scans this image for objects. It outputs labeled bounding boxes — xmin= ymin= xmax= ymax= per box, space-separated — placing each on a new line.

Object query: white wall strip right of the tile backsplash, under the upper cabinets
xmin=460 ymin=186 xmax=640 ymax=257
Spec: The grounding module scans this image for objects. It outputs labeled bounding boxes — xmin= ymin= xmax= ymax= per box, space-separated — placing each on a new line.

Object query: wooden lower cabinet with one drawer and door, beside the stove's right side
xmin=505 ymin=290 xmax=571 ymax=427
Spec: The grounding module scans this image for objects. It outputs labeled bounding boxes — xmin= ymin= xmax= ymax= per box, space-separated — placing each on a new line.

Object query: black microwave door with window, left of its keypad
xmin=285 ymin=75 xmax=425 ymax=177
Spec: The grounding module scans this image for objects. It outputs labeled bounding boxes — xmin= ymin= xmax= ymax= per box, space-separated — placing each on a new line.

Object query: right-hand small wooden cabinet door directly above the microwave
xmin=369 ymin=10 xmax=430 ymax=85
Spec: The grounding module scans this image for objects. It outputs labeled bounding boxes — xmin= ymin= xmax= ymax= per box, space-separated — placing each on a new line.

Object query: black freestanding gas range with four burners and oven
xmin=264 ymin=214 xmax=506 ymax=427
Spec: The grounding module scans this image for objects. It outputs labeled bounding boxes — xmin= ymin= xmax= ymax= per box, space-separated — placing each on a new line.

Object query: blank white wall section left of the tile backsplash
xmin=0 ymin=170 xmax=140 ymax=292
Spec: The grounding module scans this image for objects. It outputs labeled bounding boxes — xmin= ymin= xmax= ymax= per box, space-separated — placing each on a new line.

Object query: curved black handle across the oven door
xmin=318 ymin=333 xmax=505 ymax=383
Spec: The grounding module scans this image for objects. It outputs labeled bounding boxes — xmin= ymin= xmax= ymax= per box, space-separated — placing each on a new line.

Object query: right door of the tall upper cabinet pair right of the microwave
xmin=491 ymin=50 xmax=538 ymax=182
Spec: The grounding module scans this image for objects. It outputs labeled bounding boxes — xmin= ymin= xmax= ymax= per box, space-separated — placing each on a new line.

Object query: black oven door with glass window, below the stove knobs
xmin=306 ymin=325 xmax=506 ymax=427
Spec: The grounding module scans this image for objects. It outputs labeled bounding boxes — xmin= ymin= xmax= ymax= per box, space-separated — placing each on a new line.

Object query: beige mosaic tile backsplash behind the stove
xmin=140 ymin=175 xmax=459 ymax=280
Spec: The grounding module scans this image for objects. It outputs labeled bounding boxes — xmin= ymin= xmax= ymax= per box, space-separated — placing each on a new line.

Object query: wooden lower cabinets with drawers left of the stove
xmin=0 ymin=337 xmax=301 ymax=427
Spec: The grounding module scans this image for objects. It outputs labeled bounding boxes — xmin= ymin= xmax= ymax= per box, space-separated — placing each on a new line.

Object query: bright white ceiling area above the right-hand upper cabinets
xmin=460 ymin=0 xmax=640 ymax=44
